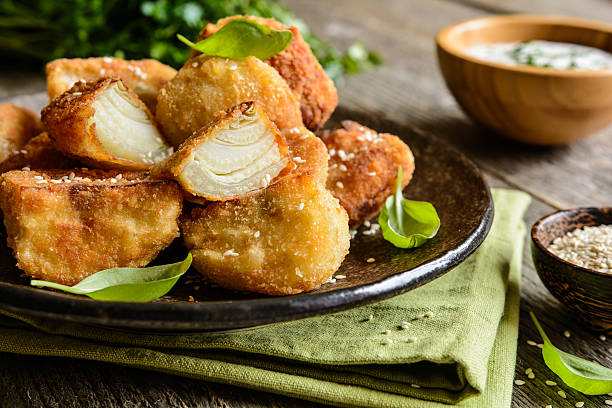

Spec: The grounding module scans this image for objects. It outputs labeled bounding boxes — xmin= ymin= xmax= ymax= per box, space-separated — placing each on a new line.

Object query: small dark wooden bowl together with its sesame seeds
xmin=531 ymin=207 xmax=612 ymax=333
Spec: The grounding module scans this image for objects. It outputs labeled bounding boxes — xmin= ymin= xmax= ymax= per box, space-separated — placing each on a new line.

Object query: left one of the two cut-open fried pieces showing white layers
xmin=42 ymin=78 xmax=172 ymax=170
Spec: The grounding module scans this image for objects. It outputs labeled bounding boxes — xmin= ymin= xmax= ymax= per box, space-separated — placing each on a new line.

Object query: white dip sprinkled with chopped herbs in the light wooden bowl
xmin=465 ymin=40 xmax=612 ymax=70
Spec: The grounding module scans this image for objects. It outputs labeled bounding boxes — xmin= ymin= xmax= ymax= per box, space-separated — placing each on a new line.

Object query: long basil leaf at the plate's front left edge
xmin=30 ymin=253 xmax=192 ymax=302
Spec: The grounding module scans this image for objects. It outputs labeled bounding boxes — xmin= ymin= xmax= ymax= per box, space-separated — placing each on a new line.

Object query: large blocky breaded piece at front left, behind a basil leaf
xmin=0 ymin=170 xmax=182 ymax=285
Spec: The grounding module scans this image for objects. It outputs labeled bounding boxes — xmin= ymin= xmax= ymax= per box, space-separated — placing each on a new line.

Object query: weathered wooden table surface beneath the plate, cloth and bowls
xmin=0 ymin=0 xmax=612 ymax=407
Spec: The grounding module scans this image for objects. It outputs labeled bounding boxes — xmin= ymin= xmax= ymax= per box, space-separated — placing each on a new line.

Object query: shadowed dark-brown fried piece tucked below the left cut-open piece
xmin=0 ymin=132 xmax=79 ymax=174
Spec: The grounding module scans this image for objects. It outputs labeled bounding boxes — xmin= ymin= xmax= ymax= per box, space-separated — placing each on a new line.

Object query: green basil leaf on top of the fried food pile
xmin=177 ymin=18 xmax=293 ymax=60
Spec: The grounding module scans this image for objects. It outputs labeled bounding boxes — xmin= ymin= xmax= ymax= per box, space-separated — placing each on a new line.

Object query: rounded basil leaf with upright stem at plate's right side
xmin=378 ymin=166 xmax=440 ymax=248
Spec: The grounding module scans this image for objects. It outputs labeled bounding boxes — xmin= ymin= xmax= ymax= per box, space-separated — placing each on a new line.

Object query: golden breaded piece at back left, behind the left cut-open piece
xmin=46 ymin=57 xmax=176 ymax=113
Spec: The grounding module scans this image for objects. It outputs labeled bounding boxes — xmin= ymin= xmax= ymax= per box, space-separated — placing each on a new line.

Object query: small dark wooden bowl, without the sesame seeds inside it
xmin=531 ymin=207 xmax=612 ymax=334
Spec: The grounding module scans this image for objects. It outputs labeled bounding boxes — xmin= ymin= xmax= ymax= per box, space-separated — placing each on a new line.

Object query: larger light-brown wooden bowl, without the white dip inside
xmin=437 ymin=15 xmax=612 ymax=146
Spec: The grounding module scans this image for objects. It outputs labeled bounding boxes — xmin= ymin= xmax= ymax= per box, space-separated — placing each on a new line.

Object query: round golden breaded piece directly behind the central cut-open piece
xmin=155 ymin=55 xmax=302 ymax=147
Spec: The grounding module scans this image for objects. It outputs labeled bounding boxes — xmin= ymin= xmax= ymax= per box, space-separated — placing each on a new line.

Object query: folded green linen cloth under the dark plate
xmin=0 ymin=189 xmax=530 ymax=408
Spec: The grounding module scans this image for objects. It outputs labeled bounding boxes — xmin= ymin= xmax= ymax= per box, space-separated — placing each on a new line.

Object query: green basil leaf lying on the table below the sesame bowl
xmin=529 ymin=312 xmax=612 ymax=395
